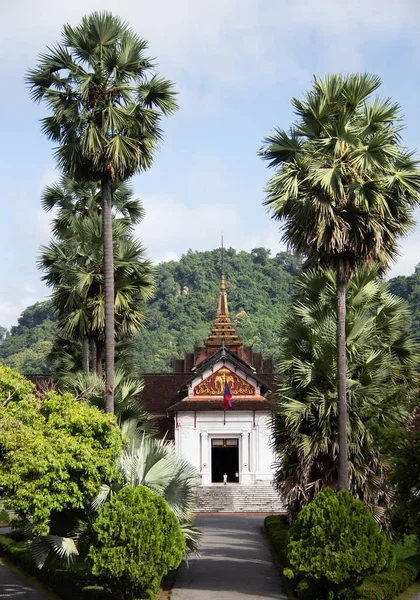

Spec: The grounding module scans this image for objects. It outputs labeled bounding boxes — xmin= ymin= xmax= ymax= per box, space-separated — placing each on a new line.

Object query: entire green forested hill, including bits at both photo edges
xmin=0 ymin=248 xmax=420 ymax=373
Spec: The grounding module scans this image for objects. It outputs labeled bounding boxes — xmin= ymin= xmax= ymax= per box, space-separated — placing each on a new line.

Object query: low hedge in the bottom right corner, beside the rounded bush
xmin=356 ymin=559 xmax=419 ymax=600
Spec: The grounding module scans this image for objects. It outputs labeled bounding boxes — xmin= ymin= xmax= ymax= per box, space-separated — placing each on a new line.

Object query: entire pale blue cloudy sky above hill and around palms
xmin=0 ymin=0 xmax=420 ymax=326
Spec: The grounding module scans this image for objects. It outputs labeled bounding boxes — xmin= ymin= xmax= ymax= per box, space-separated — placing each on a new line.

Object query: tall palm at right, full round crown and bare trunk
xmin=260 ymin=74 xmax=420 ymax=489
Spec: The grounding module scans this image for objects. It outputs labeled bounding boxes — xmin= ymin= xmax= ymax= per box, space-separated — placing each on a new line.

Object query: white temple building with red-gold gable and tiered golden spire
xmin=142 ymin=269 xmax=275 ymax=486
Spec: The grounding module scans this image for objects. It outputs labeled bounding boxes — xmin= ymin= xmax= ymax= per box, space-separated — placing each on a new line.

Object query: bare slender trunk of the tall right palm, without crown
xmin=336 ymin=264 xmax=349 ymax=490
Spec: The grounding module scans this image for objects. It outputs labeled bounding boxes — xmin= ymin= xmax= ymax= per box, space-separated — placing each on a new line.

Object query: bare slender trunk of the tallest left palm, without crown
xmin=101 ymin=176 xmax=115 ymax=413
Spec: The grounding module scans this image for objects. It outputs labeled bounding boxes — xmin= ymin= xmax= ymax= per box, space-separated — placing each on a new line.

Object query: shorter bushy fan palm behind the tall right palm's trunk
xmin=273 ymin=267 xmax=419 ymax=522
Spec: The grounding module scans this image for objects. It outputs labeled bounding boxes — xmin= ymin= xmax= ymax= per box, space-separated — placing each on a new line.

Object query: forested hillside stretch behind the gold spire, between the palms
xmin=133 ymin=248 xmax=300 ymax=373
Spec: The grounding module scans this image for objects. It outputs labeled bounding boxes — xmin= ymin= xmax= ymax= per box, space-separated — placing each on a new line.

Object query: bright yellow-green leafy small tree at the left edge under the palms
xmin=0 ymin=365 xmax=122 ymax=535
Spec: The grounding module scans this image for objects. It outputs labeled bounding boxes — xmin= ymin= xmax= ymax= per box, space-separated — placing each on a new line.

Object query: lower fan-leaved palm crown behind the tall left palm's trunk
xmin=39 ymin=214 xmax=154 ymax=376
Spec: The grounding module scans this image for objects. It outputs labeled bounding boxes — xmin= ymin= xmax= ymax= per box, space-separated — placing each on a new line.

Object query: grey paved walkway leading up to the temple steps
xmin=171 ymin=515 xmax=287 ymax=600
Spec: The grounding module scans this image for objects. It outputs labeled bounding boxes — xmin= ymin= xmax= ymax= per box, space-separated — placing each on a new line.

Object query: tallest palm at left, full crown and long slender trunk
xmin=27 ymin=12 xmax=177 ymax=412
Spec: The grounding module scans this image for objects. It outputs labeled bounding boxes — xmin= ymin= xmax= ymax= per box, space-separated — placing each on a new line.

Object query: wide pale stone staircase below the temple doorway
xmin=194 ymin=484 xmax=285 ymax=513
